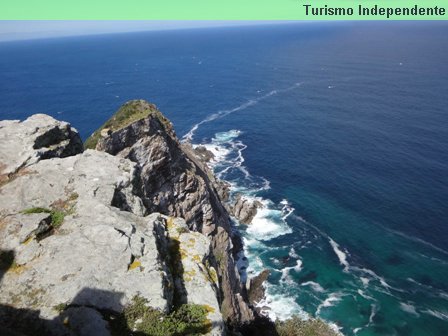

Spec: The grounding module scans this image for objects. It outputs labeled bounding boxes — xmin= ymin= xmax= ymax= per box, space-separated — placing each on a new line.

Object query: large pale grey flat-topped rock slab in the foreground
xmin=0 ymin=150 xmax=173 ymax=335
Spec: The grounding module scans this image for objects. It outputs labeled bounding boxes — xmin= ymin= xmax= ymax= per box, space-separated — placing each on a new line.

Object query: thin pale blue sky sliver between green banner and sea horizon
xmin=0 ymin=21 xmax=285 ymax=41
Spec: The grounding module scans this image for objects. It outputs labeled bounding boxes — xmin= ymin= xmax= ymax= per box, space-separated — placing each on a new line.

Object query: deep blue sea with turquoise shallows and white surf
xmin=0 ymin=22 xmax=448 ymax=336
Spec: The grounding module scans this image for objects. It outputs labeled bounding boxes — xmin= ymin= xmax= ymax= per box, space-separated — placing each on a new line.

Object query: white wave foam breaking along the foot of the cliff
xmin=187 ymin=127 xmax=304 ymax=320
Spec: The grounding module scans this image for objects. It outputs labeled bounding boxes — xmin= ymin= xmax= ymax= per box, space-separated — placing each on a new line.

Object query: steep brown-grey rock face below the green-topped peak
xmin=95 ymin=101 xmax=253 ymax=324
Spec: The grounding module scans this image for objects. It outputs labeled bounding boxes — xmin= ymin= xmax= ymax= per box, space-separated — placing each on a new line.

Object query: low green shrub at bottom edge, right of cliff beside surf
xmin=275 ymin=316 xmax=338 ymax=336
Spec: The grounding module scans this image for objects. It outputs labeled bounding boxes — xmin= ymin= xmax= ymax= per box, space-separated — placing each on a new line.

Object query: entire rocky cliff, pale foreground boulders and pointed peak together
xmin=0 ymin=100 xmax=262 ymax=335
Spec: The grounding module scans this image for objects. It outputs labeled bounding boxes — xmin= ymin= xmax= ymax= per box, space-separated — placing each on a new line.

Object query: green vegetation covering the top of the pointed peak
xmin=84 ymin=100 xmax=170 ymax=149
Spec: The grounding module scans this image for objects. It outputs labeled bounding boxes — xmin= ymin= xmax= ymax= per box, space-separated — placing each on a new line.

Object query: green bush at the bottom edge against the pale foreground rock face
xmin=110 ymin=296 xmax=213 ymax=336
